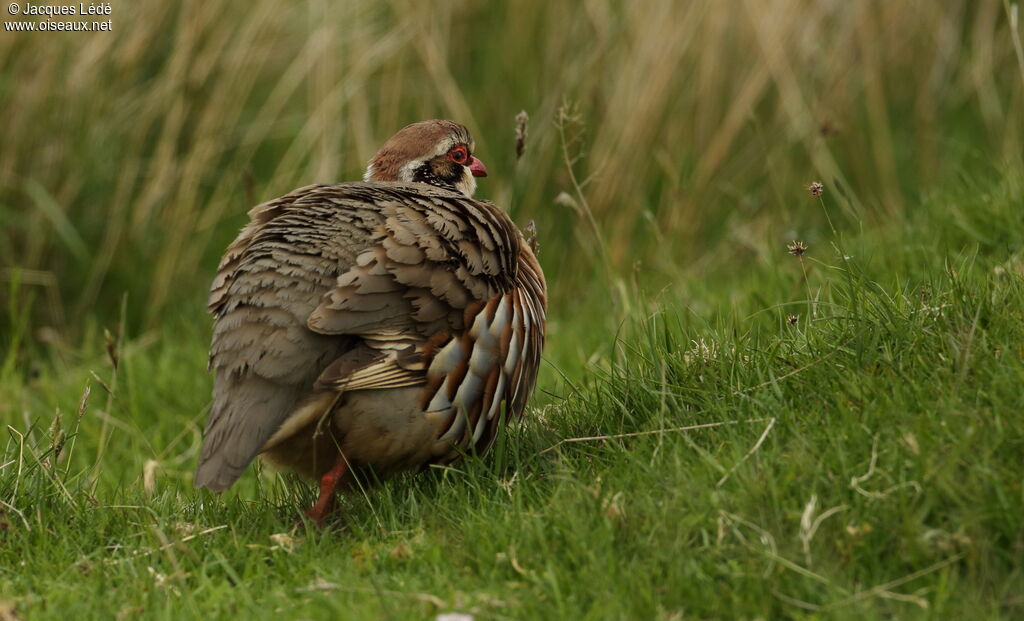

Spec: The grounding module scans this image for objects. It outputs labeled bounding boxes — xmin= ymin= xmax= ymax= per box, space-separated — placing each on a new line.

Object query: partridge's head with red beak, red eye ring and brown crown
xmin=362 ymin=121 xmax=487 ymax=197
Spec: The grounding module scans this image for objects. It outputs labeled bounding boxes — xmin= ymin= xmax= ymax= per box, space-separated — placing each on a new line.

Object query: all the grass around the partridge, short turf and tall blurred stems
xmin=0 ymin=0 xmax=1024 ymax=619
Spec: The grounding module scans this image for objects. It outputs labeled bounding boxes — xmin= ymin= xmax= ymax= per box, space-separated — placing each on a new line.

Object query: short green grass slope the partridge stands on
xmin=6 ymin=168 xmax=1024 ymax=619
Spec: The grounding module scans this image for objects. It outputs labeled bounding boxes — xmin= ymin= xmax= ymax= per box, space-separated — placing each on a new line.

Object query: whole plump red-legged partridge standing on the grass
xmin=196 ymin=121 xmax=547 ymax=523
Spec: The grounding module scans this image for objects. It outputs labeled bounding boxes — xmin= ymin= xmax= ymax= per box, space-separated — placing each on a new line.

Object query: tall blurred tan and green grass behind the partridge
xmin=0 ymin=0 xmax=1024 ymax=346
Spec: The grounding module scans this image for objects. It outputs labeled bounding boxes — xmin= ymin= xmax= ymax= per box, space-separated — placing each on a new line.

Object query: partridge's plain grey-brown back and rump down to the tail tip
xmin=195 ymin=185 xmax=378 ymax=491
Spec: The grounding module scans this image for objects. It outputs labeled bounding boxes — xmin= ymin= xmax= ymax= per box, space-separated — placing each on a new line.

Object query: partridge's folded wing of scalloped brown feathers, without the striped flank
xmin=308 ymin=193 xmax=519 ymax=340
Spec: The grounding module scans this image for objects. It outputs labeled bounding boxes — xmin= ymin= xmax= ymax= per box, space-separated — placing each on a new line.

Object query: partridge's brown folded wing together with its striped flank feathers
xmin=309 ymin=184 xmax=547 ymax=457
